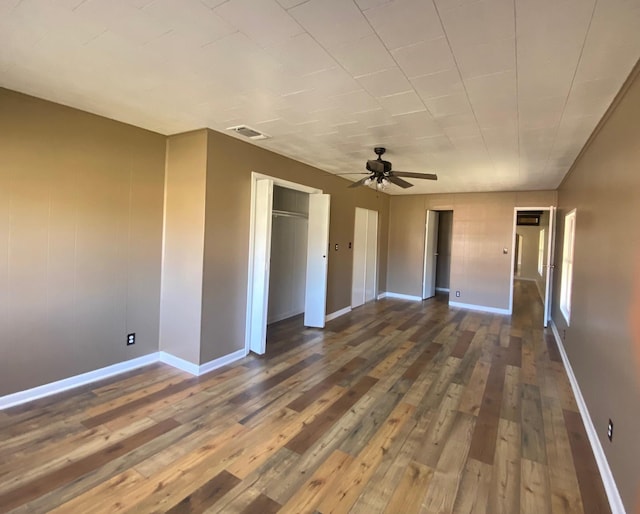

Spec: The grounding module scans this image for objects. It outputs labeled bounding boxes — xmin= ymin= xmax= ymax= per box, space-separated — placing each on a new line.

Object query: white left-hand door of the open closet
xmin=248 ymin=179 xmax=273 ymax=355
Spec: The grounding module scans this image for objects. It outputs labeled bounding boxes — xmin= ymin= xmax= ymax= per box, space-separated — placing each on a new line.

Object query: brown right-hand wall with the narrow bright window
xmin=553 ymin=61 xmax=640 ymax=512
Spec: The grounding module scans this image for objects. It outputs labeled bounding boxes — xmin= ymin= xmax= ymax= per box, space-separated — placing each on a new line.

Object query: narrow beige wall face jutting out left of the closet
xmin=159 ymin=130 xmax=207 ymax=364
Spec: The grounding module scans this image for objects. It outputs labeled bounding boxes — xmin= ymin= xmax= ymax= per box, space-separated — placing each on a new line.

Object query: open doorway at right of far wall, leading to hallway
xmin=510 ymin=207 xmax=555 ymax=327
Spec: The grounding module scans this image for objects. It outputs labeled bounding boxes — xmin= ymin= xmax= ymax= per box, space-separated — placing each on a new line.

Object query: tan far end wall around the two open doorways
xmin=387 ymin=191 xmax=556 ymax=309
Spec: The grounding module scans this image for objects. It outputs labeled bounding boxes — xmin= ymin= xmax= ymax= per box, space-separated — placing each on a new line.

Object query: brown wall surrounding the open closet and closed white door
xmin=200 ymin=130 xmax=389 ymax=363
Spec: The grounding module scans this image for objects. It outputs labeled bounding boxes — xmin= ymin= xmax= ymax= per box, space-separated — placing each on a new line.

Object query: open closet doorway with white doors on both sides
xmin=245 ymin=172 xmax=330 ymax=354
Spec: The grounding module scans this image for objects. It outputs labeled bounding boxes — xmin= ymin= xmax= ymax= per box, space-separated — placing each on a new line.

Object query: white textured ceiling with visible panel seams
xmin=0 ymin=0 xmax=640 ymax=194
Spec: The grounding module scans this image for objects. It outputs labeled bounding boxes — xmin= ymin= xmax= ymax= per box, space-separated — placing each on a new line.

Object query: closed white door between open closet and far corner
xmin=351 ymin=207 xmax=378 ymax=307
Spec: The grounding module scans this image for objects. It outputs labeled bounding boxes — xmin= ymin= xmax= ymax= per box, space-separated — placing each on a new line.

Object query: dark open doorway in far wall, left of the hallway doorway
xmin=422 ymin=210 xmax=453 ymax=299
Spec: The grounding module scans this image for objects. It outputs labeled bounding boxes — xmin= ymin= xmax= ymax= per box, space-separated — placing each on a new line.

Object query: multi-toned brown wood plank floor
xmin=0 ymin=281 xmax=610 ymax=514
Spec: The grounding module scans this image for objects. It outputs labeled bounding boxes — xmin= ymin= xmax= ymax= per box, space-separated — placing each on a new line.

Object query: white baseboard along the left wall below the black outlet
xmin=0 ymin=352 xmax=158 ymax=409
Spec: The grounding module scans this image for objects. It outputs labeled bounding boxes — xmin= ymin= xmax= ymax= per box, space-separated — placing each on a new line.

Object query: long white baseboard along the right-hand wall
xmin=550 ymin=319 xmax=626 ymax=514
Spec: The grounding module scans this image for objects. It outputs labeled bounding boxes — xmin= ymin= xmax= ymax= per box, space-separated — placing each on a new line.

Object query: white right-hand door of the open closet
xmin=304 ymin=194 xmax=330 ymax=328
